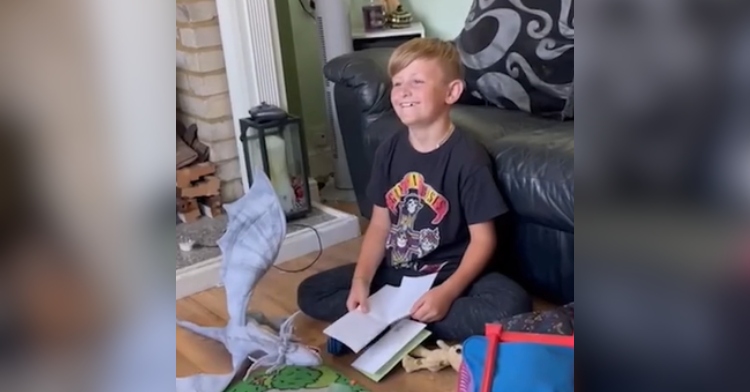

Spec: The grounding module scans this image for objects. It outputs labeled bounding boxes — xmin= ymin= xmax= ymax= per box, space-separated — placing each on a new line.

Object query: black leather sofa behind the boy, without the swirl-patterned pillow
xmin=324 ymin=48 xmax=574 ymax=304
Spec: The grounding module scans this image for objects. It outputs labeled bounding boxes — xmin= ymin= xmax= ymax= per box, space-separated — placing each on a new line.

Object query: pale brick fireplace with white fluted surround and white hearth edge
xmin=174 ymin=0 xmax=360 ymax=299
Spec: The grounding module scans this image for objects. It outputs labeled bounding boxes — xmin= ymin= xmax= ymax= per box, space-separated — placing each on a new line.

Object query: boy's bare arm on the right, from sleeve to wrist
xmin=441 ymin=221 xmax=497 ymax=298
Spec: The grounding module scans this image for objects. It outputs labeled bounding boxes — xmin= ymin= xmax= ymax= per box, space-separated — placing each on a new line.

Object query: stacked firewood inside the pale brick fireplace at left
xmin=176 ymin=122 xmax=222 ymax=223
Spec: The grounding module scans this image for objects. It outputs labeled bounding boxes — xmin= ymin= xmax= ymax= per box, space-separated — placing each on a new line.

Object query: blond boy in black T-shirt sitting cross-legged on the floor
xmin=298 ymin=38 xmax=531 ymax=341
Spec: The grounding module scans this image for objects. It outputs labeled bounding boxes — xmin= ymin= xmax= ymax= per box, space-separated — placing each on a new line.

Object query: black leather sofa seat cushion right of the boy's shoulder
xmin=451 ymin=105 xmax=574 ymax=232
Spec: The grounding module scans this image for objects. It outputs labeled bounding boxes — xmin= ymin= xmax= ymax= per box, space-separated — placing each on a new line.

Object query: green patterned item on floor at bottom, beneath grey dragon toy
xmin=225 ymin=366 xmax=368 ymax=392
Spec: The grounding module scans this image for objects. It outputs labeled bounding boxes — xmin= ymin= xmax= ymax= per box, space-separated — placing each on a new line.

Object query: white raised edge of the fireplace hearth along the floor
xmin=176 ymin=203 xmax=361 ymax=299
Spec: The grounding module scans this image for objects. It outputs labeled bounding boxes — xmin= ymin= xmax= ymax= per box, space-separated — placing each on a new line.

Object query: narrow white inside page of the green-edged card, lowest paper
xmin=352 ymin=319 xmax=426 ymax=374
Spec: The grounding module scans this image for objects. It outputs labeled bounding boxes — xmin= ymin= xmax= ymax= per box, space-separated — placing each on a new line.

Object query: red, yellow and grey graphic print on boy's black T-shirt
xmin=385 ymin=172 xmax=450 ymax=269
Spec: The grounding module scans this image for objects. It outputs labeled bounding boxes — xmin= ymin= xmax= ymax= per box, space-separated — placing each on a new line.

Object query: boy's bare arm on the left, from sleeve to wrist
xmin=353 ymin=205 xmax=391 ymax=286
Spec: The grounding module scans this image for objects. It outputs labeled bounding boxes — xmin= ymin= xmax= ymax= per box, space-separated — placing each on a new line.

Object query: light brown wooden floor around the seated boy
xmin=177 ymin=238 xmax=457 ymax=392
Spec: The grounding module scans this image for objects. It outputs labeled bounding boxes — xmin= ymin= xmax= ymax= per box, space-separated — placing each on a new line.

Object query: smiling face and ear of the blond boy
xmin=391 ymin=59 xmax=463 ymax=127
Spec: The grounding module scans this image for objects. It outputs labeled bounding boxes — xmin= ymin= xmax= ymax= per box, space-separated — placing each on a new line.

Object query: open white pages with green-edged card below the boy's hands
xmin=323 ymin=274 xmax=437 ymax=381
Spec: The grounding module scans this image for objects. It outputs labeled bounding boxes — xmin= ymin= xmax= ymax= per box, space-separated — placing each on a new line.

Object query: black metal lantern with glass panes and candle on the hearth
xmin=240 ymin=114 xmax=312 ymax=220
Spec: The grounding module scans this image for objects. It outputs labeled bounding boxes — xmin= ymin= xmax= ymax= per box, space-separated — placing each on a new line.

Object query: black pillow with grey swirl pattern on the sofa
xmin=455 ymin=0 xmax=573 ymax=119
